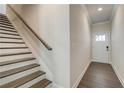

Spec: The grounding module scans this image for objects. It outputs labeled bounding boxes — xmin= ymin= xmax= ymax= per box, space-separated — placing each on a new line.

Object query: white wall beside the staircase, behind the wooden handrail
xmin=7 ymin=4 xmax=70 ymax=87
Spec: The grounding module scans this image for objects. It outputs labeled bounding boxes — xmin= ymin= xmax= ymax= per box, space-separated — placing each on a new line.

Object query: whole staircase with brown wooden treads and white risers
xmin=0 ymin=14 xmax=52 ymax=88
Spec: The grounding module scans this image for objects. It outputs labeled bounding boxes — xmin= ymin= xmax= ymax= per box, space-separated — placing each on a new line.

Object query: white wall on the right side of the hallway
xmin=111 ymin=5 xmax=124 ymax=86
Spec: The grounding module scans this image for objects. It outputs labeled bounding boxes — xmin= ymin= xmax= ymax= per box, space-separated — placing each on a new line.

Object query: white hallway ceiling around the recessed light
xmin=86 ymin=4 xmax=114 ymax=23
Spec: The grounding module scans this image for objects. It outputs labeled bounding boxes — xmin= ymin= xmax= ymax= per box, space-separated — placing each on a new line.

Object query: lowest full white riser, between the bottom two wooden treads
xmin=19 ymin=74 xmax=46 ymax=88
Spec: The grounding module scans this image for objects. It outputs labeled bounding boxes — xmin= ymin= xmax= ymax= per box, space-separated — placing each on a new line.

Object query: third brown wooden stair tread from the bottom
xmin=0 ymin=64 xmax=40 ymax=78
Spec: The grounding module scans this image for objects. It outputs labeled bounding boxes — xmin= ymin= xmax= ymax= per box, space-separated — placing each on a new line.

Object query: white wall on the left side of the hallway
xmin=70 ymin=5 xmax=91 ymax=87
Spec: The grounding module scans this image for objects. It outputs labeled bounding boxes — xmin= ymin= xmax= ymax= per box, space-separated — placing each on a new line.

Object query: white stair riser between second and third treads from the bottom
xmin=0 ymin=67 xmax=40 ymax=85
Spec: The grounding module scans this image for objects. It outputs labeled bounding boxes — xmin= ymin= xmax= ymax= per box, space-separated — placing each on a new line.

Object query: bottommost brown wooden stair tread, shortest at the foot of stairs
xmin=30 ymin=78 xmax=52 ymax=88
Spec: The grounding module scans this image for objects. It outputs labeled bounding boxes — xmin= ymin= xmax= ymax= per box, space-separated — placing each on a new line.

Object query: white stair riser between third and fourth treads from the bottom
xmin=0 ymin=60 xmax=36 ymax=72
